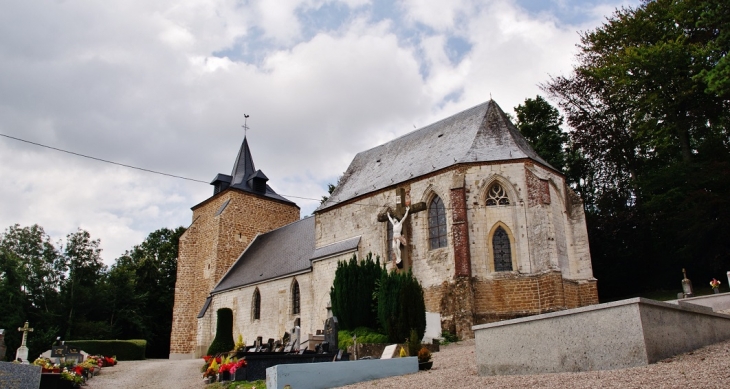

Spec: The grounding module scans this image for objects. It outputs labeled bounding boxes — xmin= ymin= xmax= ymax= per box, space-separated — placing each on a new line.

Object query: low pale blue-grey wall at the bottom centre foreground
xmin=266 ymin=357 xmax=418 ymax=389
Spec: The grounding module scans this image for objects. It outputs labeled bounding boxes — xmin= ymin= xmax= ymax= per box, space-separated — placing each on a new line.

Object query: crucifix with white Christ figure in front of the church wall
xmin=378 ymin=188 xmax=426 ymax=270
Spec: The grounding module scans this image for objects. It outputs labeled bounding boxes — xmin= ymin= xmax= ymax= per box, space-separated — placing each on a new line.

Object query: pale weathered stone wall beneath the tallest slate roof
xmin=316 ymin=161 xmax=598 ymax=337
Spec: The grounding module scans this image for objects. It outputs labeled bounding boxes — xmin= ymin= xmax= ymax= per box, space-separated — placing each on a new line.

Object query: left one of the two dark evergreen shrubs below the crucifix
xmin=330 ymin=253 xmax=385 ymax=330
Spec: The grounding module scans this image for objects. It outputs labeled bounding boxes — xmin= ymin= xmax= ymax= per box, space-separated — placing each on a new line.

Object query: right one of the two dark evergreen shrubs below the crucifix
xmin=377 ymin=270 xmax=426 ymax=343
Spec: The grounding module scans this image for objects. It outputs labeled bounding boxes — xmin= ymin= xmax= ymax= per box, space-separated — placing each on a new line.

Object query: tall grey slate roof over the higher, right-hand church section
xmin=315 ymin=100 xmax=555 ymax=212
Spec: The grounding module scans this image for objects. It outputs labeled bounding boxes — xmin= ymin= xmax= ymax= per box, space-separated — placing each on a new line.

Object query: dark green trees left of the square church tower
xmin=0 ymin=224 xmax=185 ymax=357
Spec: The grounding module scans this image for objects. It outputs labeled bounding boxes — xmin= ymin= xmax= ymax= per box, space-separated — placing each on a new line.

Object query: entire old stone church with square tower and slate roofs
xmin=170 ymin=100 xmax=598 ymax=358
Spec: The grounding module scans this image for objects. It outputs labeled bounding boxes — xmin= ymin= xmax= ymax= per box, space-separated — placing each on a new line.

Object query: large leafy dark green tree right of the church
xmin=544 ymin=0 xmax=730 ymax=296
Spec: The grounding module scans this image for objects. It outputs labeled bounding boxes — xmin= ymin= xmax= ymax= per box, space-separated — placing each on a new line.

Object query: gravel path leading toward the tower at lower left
xmin=82 ymin=359 xmax=205 ymax=389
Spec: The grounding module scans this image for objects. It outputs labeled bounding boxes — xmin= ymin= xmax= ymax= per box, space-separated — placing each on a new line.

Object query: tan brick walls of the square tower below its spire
xmin=170 ymin=189 xmax=299 ymax=354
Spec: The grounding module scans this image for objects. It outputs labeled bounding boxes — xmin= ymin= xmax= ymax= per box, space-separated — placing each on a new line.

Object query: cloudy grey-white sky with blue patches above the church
xmin=0 ymin=0 xmax=638 ymax=264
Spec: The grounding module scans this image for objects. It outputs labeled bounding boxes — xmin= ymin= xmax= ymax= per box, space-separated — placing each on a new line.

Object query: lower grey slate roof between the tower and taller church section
xmin=211 ymin=216 xmax=360 ymax=294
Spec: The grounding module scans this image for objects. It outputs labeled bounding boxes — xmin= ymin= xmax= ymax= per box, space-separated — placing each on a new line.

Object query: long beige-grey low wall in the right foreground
xmin=473 ymin=298 xmax=730 ymax=375
